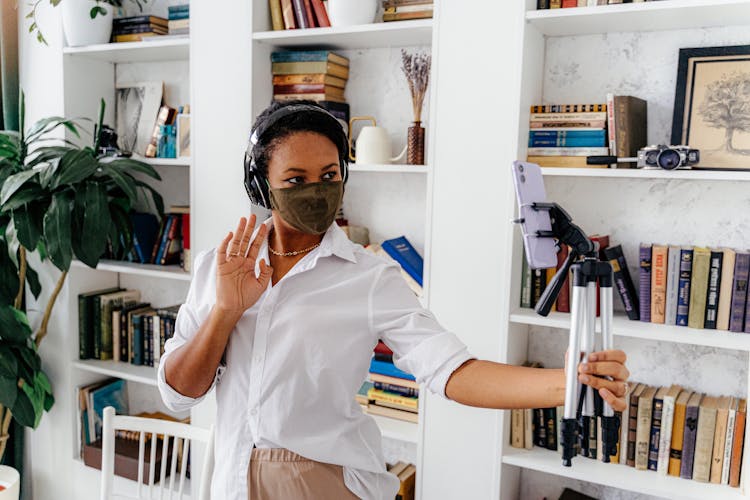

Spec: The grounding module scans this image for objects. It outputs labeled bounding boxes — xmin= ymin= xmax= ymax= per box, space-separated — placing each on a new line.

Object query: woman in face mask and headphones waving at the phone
xmin=158 ymin=102 xmax=628 ymax=500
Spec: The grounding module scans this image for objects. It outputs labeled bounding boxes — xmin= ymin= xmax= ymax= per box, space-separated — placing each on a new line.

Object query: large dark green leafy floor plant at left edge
xmin=0 ymin=94 xmax=164 ymax=457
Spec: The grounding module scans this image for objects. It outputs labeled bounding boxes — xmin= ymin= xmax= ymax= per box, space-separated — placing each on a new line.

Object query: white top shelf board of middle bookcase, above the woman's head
xmin=253 ymin=19 xmax=432 ymax=49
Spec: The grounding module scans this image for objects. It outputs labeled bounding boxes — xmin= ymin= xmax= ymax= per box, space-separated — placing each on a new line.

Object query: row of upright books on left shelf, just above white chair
xmin=78 ymin=287 xmax=180 ymax=366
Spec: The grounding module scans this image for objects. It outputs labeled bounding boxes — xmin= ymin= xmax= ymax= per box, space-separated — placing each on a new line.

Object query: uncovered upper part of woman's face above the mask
xmin=268 ymin=132 xmax=342 ymax=189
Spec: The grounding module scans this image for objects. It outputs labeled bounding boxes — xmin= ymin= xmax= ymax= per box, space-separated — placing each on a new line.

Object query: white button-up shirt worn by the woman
xmin=158 ymin=219 xmax=473 ymax=500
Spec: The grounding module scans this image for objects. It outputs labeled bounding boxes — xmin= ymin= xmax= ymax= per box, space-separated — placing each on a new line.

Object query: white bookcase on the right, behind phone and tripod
xmin=498 ymin=0 xmax=750 ymax=500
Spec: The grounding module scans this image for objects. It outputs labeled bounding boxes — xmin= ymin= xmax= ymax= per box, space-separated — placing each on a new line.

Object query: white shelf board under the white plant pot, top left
xmin=63 ymin=36 xmax=190 ymax=63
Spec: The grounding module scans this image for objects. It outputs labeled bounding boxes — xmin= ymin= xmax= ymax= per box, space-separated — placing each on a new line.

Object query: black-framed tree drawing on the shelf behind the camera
xmin=671 ymin=45 xmax=750 ymax=170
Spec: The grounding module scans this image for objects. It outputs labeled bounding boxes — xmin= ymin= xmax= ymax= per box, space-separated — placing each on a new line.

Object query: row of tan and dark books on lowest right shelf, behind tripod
xmin=511 ymin=378 xmax=747 ymax=488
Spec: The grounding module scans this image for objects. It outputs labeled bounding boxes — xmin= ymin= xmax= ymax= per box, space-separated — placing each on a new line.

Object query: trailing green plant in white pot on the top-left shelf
xmin=26 ymin=0 xmax=147 ymax=47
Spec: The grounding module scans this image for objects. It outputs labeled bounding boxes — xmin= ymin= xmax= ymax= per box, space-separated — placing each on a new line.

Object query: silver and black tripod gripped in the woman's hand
xmin=531 ymin=203 xmax=620 ymax=467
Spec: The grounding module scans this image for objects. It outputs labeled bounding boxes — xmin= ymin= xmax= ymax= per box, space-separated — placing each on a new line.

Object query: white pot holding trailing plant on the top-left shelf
xmin=62 ymin=0 xmax=114 ymax=47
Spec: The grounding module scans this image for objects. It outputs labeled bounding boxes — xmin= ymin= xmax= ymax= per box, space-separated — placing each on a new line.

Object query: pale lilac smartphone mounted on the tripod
xmin=513 ymin=161 xmax=557 ymax=269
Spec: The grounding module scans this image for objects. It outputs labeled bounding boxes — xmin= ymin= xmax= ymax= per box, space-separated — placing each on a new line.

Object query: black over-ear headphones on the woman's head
xmin=244 ymin=104 xmax=349 ymax=210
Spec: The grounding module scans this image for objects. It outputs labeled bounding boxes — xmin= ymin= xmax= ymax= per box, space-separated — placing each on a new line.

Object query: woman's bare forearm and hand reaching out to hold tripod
xmin=445 ymin=350 xmax=630 ymax=411
